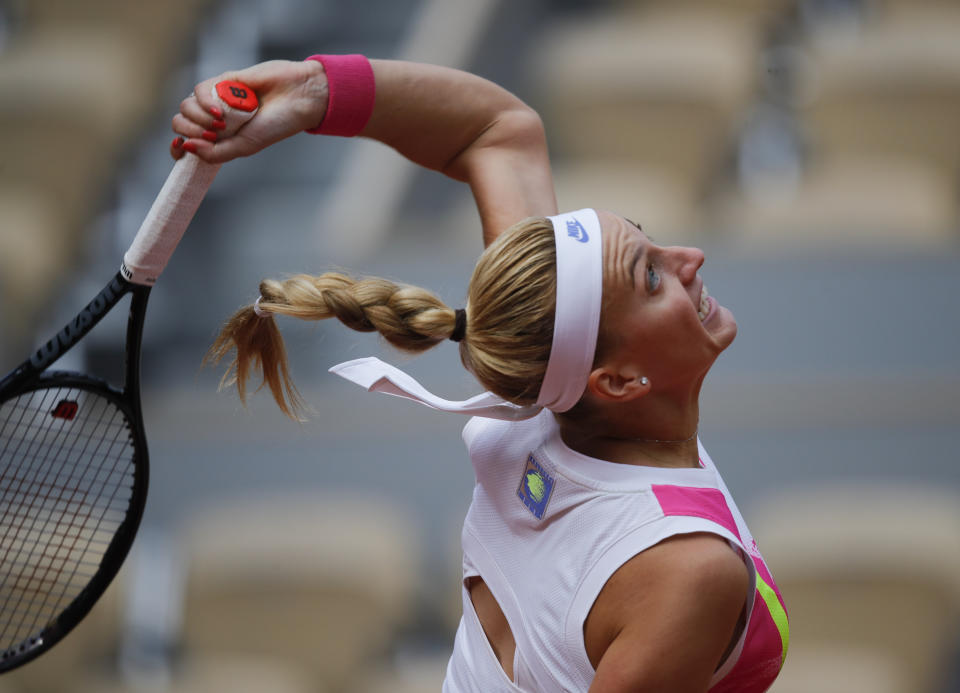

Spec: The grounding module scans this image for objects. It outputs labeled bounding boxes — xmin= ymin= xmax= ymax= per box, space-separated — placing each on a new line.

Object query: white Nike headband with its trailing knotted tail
xmin=330 ymin=209 xmax=603 ymax=421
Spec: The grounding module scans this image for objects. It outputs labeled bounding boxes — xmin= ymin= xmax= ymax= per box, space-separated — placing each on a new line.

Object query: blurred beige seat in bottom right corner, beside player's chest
xmin=747 ymin=482 xmax=960 ymax=693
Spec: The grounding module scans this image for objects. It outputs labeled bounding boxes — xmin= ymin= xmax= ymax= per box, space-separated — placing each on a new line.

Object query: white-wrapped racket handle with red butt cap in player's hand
xmin=120 ymin=81 xmax=258 ymax=286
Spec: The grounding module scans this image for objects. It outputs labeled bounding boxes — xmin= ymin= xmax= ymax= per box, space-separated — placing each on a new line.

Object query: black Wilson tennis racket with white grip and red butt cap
xmin=0 ymin=81 xmax=258 ymax=672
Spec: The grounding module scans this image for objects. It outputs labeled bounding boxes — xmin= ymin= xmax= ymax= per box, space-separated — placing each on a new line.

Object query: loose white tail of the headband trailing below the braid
xmin=330 ymin=356 xmax=543 ymax=421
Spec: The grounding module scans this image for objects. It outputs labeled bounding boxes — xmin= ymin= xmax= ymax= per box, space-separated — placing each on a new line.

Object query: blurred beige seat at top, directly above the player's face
xmin=531 ymin=8 xmax=760 ymax=195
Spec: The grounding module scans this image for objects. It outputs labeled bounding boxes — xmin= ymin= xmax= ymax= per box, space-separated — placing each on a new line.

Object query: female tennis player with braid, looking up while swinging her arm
xmin=171 ymin=56 xmax=788 ymax=693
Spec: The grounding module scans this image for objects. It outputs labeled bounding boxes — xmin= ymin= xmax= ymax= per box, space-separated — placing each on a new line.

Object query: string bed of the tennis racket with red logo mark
xmin=0 ymin=388 xmax=135 ymax=653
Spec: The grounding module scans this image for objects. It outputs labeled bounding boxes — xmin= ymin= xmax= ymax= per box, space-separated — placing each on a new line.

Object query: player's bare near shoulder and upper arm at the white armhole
xmin=584 ymin=533 xmax=750 ymax=691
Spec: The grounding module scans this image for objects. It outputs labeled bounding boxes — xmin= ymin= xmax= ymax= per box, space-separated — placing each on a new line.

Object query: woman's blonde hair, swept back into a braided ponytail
xmin=204 ymin=218 xmax=557 ymax=419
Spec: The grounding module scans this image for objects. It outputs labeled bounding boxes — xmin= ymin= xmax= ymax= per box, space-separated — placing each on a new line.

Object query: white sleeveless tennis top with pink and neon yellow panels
xmin=443 ymin=411 xmax=788 ymax=693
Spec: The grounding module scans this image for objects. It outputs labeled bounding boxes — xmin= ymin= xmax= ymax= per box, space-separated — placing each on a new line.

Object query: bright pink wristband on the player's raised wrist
xmin=307 ymin=54 xmax=376 ymax=137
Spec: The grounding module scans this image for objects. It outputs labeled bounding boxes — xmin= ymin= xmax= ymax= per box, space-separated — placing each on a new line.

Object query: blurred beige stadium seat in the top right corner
xmin=800 ymin=3 xmax=960 ymax=184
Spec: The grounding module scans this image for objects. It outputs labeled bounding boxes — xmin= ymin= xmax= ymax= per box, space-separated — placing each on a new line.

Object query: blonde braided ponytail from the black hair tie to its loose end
xmin=204 ymin=272 xmax=456 ymax=420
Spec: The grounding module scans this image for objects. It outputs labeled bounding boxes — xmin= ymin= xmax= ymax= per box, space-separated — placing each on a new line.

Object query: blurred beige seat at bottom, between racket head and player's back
xmin=177 ymin=493 xmax=420 ymax=691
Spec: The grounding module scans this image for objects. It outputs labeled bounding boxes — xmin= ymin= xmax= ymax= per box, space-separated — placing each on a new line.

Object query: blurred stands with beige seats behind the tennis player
xmin=0 ymin=0 xmax=960 ymax=693
